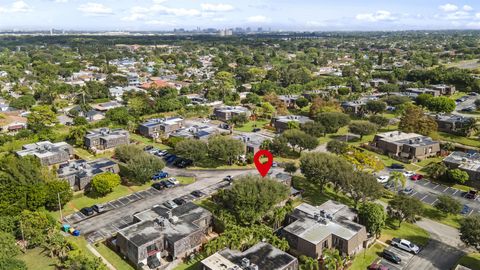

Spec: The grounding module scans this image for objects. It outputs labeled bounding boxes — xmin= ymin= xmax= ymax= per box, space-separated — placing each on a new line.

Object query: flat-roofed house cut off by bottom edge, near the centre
xmin=200 ymin=242 xmax=299 ymax=270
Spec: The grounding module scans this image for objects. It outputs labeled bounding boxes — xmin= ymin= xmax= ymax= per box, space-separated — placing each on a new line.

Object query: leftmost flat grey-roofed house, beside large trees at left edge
xmin=16 ymin=141 xmax=73 ymax=166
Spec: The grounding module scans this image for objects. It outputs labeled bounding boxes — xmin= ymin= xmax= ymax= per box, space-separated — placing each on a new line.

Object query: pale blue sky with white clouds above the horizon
xmin=0 ymin=0 xmax=480 ymax=31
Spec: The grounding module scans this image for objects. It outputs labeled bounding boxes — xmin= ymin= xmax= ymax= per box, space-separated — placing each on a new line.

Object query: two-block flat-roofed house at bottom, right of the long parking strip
xmin=115 ymin=202 xmax=213 ymax=269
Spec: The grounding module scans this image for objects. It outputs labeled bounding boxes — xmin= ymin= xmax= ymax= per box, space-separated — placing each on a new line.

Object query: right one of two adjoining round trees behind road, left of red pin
xmin=208 ymin=135 xmax=245 ymax=164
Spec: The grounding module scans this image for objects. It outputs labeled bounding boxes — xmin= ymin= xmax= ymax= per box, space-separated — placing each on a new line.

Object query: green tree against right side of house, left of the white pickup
xmin=358 ymin=202 xmax=387 ymax=238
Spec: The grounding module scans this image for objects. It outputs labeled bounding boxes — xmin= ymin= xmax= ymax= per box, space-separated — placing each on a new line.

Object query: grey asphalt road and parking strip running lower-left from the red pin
xmin=70 ymin=168 xmax=281 ymax=243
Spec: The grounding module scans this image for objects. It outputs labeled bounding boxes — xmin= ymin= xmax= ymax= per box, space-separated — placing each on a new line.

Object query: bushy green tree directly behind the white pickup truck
xmin=387 ymin=195 xmax=423 ymax=227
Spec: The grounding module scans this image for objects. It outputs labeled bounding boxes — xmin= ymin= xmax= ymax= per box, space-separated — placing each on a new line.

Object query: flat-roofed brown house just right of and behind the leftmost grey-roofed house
xmin=83 ymin=128 xmax=129 ymax=150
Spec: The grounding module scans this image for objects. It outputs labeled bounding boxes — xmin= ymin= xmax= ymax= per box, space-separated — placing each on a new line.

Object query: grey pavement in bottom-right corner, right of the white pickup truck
xmin=405 ymin=219 xmax=466 ymax=270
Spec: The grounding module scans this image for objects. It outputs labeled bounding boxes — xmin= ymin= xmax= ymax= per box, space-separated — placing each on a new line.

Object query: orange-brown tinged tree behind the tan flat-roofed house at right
xmin=398 ymin=106 xmax=438 ymax=135
